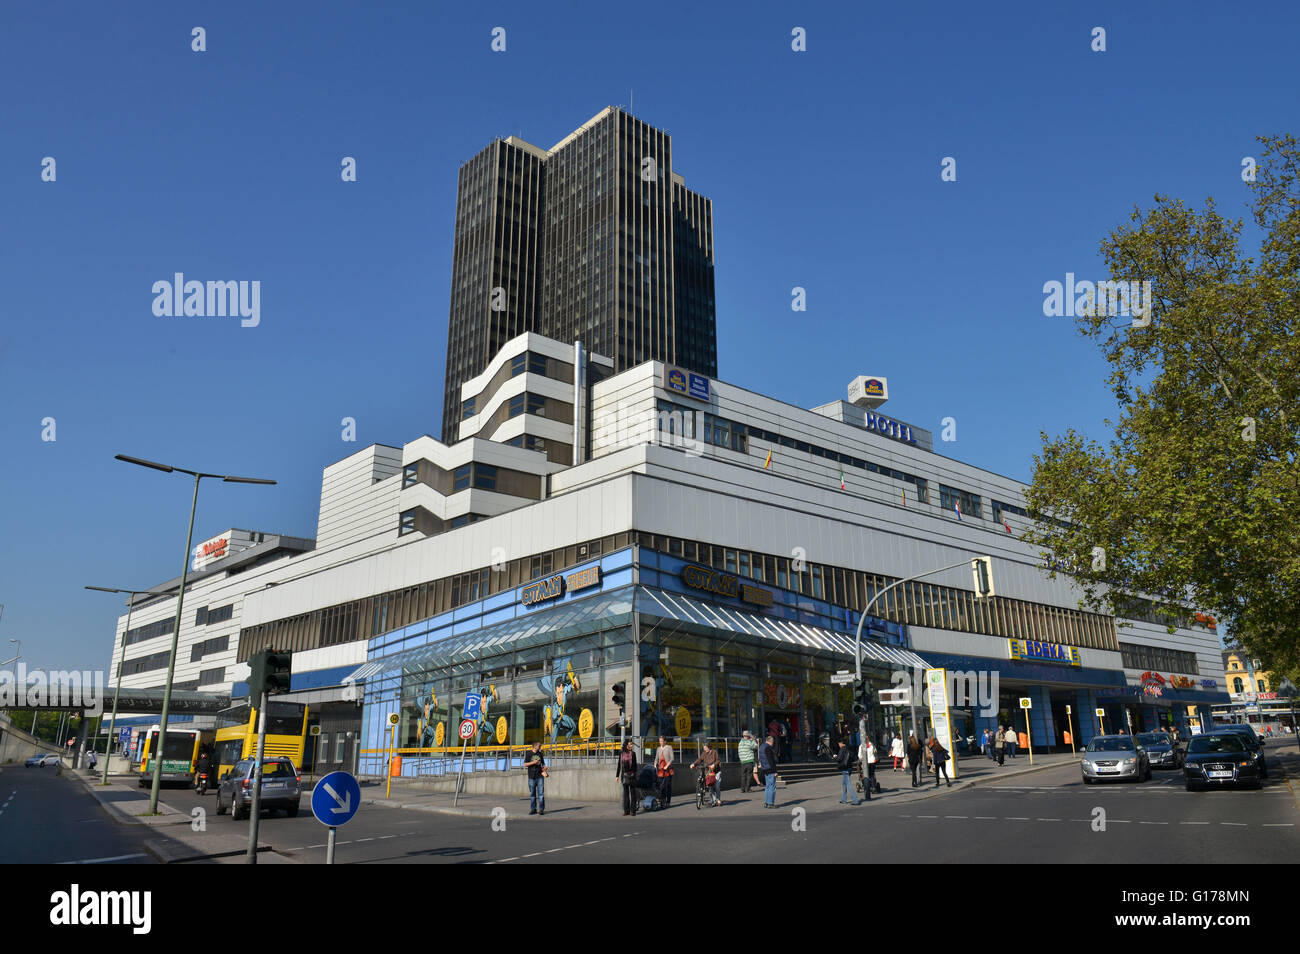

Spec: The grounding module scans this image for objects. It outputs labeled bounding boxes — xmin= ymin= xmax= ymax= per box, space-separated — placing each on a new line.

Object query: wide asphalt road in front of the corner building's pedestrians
xmin=144 ymin=743 xmax=1300 ymax=864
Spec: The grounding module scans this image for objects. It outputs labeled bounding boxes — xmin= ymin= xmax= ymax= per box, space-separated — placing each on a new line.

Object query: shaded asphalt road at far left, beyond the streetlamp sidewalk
xmin=0 ymin=763 xmax=153 ymax=864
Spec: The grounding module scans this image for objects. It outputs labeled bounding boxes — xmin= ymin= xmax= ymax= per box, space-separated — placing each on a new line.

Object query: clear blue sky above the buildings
xmin=0 ymin=3 xmax=1300 ymax=668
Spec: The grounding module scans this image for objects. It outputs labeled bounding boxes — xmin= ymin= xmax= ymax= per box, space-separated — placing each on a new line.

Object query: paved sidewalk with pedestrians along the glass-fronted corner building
xmin=361 ymin=753 xmax=1079 ymax=819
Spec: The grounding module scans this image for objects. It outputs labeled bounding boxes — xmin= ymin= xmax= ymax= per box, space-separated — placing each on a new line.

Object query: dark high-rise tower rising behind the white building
xmin=442 ymin=109 xmax=718 ymax=443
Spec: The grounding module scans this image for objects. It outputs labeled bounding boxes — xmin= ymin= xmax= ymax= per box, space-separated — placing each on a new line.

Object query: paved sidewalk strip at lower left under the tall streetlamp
xmin=62 ymin=767 xmax=298 ymax=864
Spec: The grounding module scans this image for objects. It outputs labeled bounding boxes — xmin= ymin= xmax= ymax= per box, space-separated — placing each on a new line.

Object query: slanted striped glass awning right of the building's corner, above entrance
xmin=636 ymin=586 xmax=928 ymax=669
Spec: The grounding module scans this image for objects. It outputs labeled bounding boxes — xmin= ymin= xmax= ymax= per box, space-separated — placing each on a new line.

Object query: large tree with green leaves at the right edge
xmin=1026 ymin=135 xmax=1300 ymax=680
